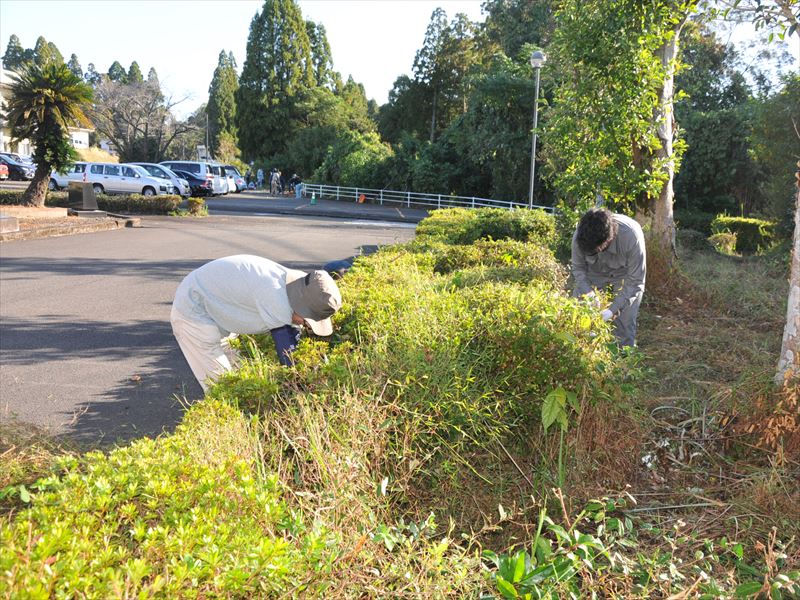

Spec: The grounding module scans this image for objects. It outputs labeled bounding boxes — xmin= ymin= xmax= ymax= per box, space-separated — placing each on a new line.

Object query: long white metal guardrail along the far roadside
xmin=296 ymin=183 xmax=553 ymax=212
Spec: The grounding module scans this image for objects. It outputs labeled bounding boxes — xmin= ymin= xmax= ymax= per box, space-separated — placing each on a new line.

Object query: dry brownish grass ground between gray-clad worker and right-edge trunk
xmin=632 ymin=238 xmax=800 ymax=564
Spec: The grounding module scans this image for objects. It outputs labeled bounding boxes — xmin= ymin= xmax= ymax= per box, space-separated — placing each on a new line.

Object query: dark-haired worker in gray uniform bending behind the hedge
xmin=572 ymin=208 xmax=647 ymax=346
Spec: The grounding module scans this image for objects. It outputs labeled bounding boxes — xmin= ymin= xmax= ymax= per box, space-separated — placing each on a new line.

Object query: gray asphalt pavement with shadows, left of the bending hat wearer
xmin=0 ymin=216 xmax=414 ymax=445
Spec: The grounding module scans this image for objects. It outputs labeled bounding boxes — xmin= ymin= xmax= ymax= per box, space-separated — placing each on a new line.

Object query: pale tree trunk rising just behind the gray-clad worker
xmin=651 ymin=21 xmax=683 ymax=262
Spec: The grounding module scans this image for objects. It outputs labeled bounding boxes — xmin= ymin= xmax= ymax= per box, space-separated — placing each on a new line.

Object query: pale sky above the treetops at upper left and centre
xmin=0 ymin=0 xmax=485 ymax=117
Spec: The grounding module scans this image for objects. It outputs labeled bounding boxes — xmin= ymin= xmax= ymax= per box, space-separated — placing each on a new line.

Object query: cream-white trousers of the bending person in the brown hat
xmin=170 ymin=306 xmax=240 ymax=392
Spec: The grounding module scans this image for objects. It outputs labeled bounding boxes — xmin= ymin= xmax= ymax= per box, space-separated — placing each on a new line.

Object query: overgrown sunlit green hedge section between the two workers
xmin=335 ymin=251 xmax=615 ymax=460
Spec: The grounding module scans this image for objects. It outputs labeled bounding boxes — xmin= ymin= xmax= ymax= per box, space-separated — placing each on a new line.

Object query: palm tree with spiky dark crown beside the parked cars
xmin=5 ymin=61 xmax=92 ymax=206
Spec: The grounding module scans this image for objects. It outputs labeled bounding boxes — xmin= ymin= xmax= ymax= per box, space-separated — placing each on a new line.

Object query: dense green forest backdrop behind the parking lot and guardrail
xmin=3 ymin=0 xmax=800 ymax=233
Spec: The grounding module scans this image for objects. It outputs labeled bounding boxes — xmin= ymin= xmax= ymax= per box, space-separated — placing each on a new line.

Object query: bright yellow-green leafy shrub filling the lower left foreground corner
xmin=0 ymin=400 xmax=335 ymax=598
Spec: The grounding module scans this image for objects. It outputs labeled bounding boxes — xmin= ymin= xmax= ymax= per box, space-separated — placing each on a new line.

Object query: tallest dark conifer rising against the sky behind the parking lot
xmin=236 ymin=0 xmax=315 ymax=159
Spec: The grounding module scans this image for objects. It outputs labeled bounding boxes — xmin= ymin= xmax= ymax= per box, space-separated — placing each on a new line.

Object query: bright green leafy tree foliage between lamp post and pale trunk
xmin=543 ymin=0 xmax=696 ymax=208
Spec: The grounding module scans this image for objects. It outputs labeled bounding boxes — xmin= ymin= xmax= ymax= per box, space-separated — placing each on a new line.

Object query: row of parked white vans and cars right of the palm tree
xmin=49 ymin=160 xmax=246 ymax=197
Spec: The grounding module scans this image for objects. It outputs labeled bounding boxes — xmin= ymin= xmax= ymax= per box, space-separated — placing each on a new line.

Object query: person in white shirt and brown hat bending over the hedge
xmin=170 ymin=254 xmax=342 ymax=390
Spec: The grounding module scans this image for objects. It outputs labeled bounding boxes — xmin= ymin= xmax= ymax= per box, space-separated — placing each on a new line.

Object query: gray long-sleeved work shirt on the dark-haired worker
xmin=572 ymin=214 xmax=647 ymax=315
